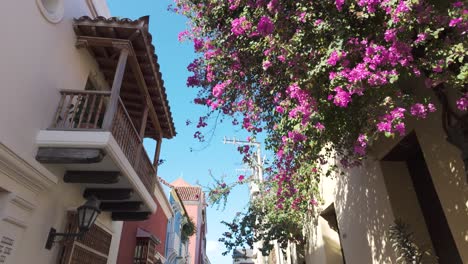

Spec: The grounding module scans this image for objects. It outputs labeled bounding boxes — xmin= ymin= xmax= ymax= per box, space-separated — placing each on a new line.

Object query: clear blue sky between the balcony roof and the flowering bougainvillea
xmin=107 ymin=0 xmax=256 ymax=264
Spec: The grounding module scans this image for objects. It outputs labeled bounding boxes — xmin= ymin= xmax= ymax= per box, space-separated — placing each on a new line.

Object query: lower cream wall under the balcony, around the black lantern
xmin=0 ymin=174 xmax=122 ymax=264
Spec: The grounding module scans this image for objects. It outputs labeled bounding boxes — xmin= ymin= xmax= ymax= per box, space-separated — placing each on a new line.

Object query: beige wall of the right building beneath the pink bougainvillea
xmin=307 ymin=81 xmax=468 ymax=264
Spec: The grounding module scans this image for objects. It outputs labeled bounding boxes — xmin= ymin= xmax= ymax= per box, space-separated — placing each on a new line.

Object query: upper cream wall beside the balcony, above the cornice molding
xmin=0 ymin=0 xmax=101 ymax=167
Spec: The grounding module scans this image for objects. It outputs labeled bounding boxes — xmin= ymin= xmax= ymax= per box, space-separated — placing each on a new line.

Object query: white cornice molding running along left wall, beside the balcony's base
xmin=0 ymin=143 xmax=58 ymax=194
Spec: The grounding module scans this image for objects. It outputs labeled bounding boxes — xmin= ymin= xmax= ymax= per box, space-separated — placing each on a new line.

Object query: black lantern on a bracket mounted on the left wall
xmin=45 ymin=196 xmax=101 ymax=249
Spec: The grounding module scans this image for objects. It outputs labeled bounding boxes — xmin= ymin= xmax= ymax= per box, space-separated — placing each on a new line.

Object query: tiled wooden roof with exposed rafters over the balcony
xmin=74 ymin=16 xmax=176 ymax=139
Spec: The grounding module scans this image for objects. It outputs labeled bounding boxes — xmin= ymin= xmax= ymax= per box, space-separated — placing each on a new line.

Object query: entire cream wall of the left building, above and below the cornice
xmin=0 ymin=0 xmax=121 ymax=264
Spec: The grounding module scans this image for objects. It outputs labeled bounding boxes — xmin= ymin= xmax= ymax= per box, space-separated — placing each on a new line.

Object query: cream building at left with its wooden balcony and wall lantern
xmin=0 ymin=0 xmax=175 ymax=264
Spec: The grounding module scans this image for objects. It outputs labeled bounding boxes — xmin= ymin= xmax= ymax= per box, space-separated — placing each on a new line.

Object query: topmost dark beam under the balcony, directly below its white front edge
xmin=36 ymin=147 xmax=105 ymax=164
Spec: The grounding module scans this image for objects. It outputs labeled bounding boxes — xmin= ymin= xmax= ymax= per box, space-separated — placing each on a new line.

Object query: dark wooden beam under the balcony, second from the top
xmin=63 ymin=171 xmax=120 ymax=184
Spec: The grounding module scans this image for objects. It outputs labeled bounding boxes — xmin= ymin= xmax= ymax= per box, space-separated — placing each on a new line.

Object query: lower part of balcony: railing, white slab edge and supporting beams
xmin=36 ymin=90 xmax=157 ymax=220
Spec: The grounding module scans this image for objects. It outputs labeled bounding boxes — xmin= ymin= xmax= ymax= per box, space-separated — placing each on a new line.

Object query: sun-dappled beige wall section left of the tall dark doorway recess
xmin=336 ymin=159 xmax=395 ymax=263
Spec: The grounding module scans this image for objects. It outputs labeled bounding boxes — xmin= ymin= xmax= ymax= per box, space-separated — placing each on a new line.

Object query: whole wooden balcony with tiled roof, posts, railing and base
xmin=36 ymin=17 xmax=176 ymax=221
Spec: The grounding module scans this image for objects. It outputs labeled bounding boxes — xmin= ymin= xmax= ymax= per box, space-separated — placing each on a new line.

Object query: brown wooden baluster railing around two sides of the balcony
xmin=51 ymin=90 xmax=156 ymax=194
